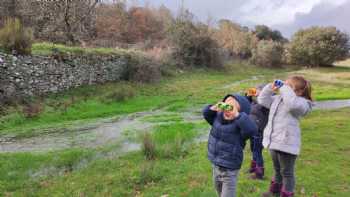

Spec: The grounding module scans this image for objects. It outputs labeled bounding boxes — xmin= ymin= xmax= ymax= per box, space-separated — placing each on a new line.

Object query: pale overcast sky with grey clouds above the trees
xmin=134 ymin=0 xmax=350 ymax=37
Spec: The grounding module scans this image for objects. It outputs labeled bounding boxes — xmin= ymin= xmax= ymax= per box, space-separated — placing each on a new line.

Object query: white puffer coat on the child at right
xmin=258 ymin=84 xmax=312 ymax=155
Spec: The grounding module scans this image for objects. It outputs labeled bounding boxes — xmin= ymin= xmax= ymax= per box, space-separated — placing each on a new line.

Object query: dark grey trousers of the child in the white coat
xmin=270 ymin=150 xmax=297 ymax=192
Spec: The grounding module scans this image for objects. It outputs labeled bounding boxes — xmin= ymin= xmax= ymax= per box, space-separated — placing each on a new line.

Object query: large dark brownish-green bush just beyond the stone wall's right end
xmin=168 ymin=17 xmax=222 ymax=68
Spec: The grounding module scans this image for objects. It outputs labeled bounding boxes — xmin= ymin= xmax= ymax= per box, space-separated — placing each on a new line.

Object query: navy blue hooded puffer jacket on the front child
xmin=203 ymin=94 xmax=258 ymax=170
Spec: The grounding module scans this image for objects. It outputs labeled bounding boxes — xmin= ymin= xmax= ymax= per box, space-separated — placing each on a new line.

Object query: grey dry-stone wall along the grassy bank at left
xmin=0 ymin=53 xmax=130 ymax=100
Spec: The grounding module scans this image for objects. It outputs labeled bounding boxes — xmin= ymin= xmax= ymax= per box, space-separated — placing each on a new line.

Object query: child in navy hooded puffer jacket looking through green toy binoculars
xmin=203 ymin=94 xmax=257 ymax=197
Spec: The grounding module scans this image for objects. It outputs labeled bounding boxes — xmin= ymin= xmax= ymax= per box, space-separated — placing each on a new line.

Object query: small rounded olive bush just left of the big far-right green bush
xmin=251 ymin=40 xmax=284 ymax=67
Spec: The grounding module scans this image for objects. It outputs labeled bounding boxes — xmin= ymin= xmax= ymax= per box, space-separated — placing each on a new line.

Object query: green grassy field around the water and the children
xmin=0 ymin=60 xmax=350 ymax=197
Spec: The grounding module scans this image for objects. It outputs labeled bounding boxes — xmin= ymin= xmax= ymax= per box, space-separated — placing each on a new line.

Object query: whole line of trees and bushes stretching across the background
xmin=0 ymin=0 xmax=350 ymax=67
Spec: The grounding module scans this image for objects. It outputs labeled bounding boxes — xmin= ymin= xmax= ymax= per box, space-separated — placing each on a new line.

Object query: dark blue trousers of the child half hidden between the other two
xmin=250 ymin=132 xmax=264 ymax=167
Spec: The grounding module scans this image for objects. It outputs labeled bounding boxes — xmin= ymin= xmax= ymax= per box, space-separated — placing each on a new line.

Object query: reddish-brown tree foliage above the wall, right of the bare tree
xmin=96 ymin=1 xmax=172 ymax=45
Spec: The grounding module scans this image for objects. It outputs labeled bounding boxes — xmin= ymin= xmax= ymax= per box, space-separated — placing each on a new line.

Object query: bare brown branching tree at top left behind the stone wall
xmin=0 ymin=0 xmax=101 ymax=44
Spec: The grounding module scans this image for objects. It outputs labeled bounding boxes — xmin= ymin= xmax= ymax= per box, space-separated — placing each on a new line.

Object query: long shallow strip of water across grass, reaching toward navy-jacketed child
xmin=0 ymin=108 xmax=202 ymax=153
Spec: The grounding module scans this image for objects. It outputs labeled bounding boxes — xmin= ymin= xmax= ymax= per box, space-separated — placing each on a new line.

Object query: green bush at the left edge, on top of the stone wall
xmin=0 ymin=19 xmax=33 ymax=55
